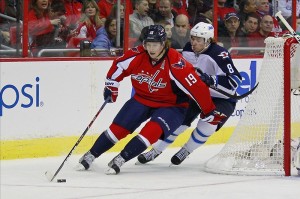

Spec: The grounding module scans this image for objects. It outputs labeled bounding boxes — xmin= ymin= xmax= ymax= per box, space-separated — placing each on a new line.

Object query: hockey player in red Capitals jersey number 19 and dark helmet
xmin=77 ymin=25 xmax=223 ymax=174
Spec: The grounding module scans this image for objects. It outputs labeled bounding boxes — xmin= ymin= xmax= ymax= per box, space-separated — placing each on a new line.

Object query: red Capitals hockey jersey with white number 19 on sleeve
xmin=107 ymin=46 xmax=215 ymax=114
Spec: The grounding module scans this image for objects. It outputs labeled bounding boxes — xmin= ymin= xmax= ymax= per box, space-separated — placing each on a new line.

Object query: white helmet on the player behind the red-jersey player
xmin=190 ymin=22 xmax=214 ymax=42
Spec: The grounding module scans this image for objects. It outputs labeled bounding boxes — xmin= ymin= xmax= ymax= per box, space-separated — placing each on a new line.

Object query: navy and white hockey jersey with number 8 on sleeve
xmin=182 ymin=42 xmax=242 ymax=99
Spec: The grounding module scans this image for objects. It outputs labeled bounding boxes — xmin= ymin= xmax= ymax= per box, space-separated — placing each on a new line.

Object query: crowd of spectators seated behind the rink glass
xmin=0 ymin=0 xmax=300 ymax=56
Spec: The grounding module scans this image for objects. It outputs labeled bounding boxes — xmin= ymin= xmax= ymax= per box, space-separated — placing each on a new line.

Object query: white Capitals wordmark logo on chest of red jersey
xmin=131 ymin=70 xmax=167 ymax=93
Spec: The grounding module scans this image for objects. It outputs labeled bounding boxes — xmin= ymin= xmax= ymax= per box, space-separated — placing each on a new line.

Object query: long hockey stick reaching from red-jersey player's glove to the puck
xmin=45 ymin=98 xmax=110 ymax=182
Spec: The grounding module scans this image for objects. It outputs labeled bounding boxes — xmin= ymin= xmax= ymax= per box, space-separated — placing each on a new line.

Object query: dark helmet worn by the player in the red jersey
xmin=144 ymin=25 xmax=167 ymax=42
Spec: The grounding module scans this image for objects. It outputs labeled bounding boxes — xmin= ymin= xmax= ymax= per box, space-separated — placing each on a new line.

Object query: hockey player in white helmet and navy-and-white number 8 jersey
xmin=138 ymin=22 xmax=242 ymax=165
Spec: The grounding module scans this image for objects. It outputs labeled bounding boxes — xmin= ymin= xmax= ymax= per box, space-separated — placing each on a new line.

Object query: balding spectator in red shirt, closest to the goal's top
xmin=248 ymin=15 xmax=274 ymax=47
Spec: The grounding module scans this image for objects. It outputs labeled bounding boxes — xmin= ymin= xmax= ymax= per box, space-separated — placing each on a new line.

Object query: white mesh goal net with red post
xmin=205 ymin=37 xmax=300 ymax=175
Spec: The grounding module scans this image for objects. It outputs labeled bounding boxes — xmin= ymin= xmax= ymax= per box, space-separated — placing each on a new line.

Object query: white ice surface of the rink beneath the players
xmin=0 ymin=145 xmax=300 ymax=199
